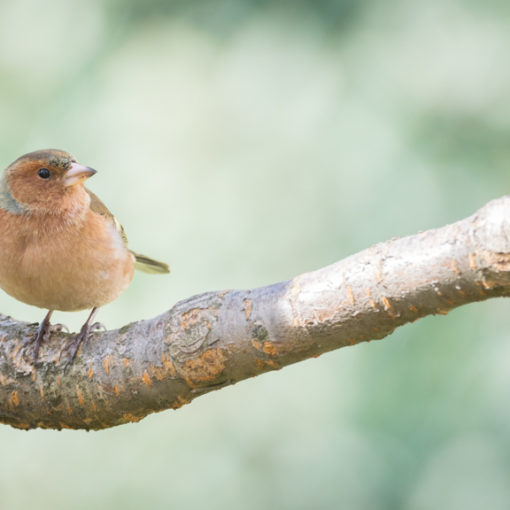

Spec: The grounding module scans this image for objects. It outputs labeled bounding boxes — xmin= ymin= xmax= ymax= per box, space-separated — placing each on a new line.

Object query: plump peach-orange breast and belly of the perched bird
xmin=0 ymin=211 xmax=134 ymax=311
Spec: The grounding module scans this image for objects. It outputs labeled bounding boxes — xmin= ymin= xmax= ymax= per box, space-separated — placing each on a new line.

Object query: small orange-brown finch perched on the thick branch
xmin=0 ymin=149 xmax=170 ymax=364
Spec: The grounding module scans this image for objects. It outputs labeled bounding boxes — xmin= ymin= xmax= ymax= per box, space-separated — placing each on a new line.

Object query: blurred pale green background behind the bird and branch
xmin=0 ymin=0 xmax=510 ymax=510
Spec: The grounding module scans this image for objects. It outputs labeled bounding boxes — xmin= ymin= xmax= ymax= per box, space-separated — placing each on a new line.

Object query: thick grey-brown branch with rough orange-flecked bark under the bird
xmin=0 ymin=197 xmax=510 ymax=429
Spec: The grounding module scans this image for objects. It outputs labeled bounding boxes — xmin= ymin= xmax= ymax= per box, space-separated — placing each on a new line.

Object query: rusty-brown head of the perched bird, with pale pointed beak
xmin=0 ymin=149 xmax=96 ymax=213
